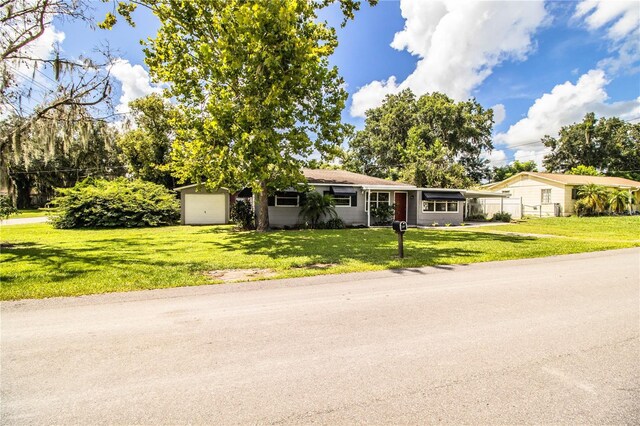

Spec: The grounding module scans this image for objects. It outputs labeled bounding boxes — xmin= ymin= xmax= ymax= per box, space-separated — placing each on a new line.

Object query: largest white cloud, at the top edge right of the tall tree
xmin=351 ymin=0 xmax=547 ymax=117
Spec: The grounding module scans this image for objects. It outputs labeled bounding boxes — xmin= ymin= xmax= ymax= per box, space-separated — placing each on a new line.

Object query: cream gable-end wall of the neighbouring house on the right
xmin=492 ymin=176 xmax=571 ymax=216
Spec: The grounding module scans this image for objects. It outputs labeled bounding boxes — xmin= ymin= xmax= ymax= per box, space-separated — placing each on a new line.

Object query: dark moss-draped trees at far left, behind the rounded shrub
xmin=0 ymin=106 xmax=124 ymax=208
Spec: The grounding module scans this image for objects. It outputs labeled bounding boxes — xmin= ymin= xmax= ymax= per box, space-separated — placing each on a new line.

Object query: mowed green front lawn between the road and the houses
xmin=0 ymin=217 xmax=640 ymax=300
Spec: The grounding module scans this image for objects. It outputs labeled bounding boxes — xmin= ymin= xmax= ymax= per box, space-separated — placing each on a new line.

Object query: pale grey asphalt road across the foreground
xmin=1 ymin=249 xmax=640 ymax=424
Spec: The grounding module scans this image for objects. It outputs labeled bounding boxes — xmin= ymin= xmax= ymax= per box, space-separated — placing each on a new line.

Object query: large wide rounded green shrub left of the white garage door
xmin=52 ymin=178 xmax=180 ymax=228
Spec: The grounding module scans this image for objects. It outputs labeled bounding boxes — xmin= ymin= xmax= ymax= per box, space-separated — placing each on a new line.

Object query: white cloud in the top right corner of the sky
xmin=574 ymin=0 xmax=640 ymax=73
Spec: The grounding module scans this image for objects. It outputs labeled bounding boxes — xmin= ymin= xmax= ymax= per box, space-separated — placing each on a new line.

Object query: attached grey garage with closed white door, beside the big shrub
xmin=176 ymin=185 xmax=229 ymax=225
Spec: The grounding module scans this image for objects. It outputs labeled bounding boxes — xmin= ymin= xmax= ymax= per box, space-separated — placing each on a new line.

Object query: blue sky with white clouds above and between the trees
xmin=47 ymin=0 xmax=640 ymax=170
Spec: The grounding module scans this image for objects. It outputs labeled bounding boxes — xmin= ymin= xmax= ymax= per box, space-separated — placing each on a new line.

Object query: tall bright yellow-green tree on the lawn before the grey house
xmin=104 ymin=0 xmax=372 ymax=230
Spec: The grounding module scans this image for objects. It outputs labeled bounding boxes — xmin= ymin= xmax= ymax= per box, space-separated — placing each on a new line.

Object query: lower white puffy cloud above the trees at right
xmin=494 ymin=70 xmax=640 ymax=153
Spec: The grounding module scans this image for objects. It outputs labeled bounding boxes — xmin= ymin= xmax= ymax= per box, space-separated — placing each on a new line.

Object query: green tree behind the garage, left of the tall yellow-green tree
xmin=118 ymin=94 xmax=176 ymax=189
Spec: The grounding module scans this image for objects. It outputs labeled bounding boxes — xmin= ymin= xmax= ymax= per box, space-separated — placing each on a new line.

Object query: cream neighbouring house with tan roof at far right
xmin=484 ymin=172 xmax=640 ymax=216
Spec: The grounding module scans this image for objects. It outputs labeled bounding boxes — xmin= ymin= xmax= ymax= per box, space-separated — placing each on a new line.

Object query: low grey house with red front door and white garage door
xmin=176 ymin=169 xmax=502 ymax=227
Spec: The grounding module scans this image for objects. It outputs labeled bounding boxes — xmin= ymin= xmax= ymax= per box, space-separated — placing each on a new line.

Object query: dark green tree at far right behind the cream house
xmin=542 ymin=112 xmax=640 ymax=180
